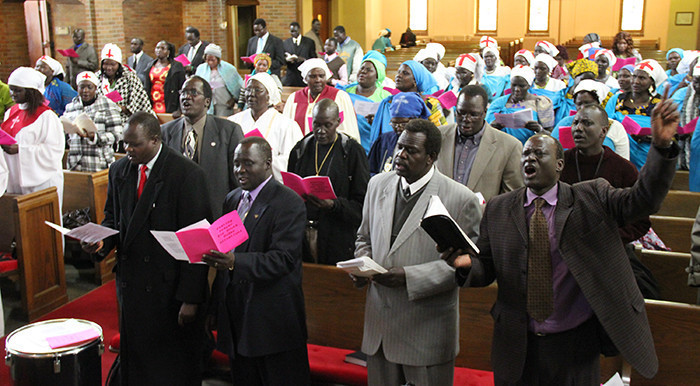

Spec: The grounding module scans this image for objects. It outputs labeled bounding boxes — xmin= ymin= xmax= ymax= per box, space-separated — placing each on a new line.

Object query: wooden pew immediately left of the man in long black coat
xmin=63 ymin=169 xmax=116 ymax=285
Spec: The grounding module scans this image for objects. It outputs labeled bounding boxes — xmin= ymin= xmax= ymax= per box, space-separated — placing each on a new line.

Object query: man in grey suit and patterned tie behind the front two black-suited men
xmin=161 ymin=75 xmax=243 ymax=219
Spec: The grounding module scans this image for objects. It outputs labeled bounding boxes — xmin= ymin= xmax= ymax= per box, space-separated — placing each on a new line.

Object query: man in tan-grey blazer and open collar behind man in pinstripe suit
xmin=436 ymin=85 xmax=523 ymax=201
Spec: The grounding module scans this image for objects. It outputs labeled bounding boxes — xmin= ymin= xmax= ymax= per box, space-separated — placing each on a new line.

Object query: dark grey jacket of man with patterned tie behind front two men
xmin=161 ymin=114 xmax=243 ymax=219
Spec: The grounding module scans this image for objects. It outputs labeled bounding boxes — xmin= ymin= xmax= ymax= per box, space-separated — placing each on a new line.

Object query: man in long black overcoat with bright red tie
xmin=83 ymin=112 xmax=211 ymax=385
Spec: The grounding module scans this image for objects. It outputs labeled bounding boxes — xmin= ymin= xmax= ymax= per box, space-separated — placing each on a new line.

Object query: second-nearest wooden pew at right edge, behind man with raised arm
xmin=635 ymin=248 xmax=698 ymax=304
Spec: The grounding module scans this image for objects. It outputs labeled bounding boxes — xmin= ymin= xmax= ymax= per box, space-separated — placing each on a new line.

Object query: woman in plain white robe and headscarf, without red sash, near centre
xmin=228 ymin=72 xmax=303 ymax=182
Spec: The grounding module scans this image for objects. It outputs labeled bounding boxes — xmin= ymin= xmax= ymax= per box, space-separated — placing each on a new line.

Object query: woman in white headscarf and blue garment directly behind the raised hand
xmin=613 ymin=59 xmax=668 ymax=169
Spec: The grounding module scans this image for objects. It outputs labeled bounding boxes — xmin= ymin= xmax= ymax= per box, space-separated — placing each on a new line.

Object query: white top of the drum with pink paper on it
xmin=5 ymin=319 xmax=102 ymax=356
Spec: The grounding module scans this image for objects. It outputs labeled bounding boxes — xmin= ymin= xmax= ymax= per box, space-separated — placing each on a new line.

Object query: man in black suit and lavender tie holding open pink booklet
xmin=203 ymin=137 xmax=310 ymax=386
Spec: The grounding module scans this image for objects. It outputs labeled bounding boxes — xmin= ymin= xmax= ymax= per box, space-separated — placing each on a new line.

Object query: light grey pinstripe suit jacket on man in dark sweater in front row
xmin=355 ymin=170 xmax=481 ymax=366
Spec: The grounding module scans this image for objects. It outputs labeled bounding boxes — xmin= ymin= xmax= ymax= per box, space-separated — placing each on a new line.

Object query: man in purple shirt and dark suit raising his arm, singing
xmin=442 ymin=93 xmax=679 ymax=385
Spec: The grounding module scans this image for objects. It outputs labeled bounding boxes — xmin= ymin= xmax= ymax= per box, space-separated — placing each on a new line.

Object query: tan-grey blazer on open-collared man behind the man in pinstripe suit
xmin=436 ymin=122 xmax=523 ymax=201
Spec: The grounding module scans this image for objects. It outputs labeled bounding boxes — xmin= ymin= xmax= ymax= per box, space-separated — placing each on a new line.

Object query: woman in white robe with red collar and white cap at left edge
xmin=1 ymin=67 xmax=65 ymax=205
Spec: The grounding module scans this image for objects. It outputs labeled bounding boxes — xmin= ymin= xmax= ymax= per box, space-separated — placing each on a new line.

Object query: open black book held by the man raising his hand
xmin=420 ymin=196 xmax=479 ymax=256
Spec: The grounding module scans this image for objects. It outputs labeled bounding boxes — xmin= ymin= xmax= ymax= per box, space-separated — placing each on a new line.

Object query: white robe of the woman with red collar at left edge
xmin=4 ymin=106 xmax=66 ymax=207
